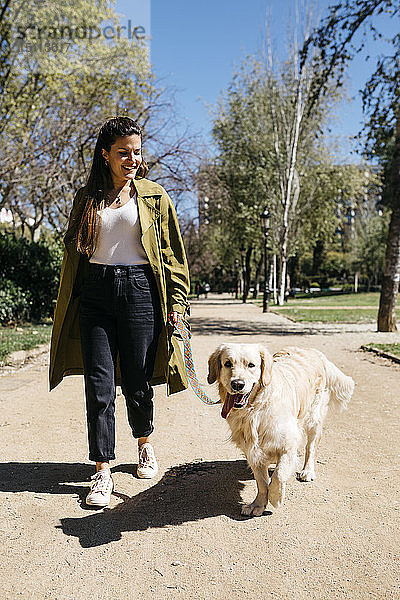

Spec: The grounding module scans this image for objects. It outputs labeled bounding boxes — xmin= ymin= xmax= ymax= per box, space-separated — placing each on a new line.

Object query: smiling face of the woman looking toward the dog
xmin=102 ymin=135 xmax=142 ymax=186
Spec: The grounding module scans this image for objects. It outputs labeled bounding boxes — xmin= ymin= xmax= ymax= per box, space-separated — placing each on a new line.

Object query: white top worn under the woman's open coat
xmin=89 ymin=196 xmax=149 ymax=265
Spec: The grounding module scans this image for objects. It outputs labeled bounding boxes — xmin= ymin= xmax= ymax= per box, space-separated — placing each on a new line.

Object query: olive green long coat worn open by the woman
xmin=49 ymin=178 xmax=189 ymax=395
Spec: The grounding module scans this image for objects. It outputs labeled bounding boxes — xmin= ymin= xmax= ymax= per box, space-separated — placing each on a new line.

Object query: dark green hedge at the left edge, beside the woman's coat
xmin=0 ymin=233 xmax=62 ymax=321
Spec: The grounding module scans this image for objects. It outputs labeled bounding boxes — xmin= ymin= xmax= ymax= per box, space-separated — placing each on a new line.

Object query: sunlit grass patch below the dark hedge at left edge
xmin=0 ymin=324 xmax=51 ymax=365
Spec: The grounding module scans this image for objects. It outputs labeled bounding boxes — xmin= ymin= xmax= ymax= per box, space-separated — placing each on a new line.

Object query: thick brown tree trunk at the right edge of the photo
xmin=378 ymin=115 xmax=400 ymax=331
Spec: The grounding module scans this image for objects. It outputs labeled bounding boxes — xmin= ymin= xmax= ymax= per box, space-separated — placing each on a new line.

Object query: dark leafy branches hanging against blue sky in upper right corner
xmin=301 ymin=0 xmax=400 ymax=131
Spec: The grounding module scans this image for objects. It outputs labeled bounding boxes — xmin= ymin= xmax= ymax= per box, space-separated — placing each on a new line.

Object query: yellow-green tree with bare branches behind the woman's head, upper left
xmin=0 ymin=0 xmax=198 ymax=238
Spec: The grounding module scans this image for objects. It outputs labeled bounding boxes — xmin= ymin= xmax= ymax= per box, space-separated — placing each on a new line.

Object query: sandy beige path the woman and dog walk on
xmin=0 ymin=296 xmax=400 ymax=600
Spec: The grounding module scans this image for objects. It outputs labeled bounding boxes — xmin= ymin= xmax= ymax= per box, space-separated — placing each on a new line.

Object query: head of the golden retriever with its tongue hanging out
xmin=207 ymin=344 xmax=272 ymax=419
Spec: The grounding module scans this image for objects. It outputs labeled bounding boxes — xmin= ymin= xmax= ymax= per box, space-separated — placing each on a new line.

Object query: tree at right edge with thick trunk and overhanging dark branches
xmin=302 ymin=0 xmax=400 ymax=331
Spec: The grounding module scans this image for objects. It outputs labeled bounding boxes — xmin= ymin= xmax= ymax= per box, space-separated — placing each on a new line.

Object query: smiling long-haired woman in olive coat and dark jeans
xmin=50 ymin=117 xmax=189 ymax=507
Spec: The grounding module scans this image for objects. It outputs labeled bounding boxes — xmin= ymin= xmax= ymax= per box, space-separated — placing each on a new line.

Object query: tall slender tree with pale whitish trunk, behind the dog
xmin=256 ymin=44 xmax=344 ymax=305
